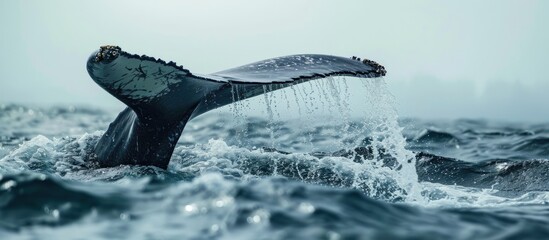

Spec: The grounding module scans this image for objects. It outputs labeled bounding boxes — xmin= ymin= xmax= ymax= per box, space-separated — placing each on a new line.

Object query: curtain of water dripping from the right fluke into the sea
xmin=222 ymin=77 xmax=421 ymax=201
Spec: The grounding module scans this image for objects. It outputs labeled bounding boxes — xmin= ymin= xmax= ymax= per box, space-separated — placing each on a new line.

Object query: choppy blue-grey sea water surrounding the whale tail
xmin=0 ymin=79 xmax=549 ymax=239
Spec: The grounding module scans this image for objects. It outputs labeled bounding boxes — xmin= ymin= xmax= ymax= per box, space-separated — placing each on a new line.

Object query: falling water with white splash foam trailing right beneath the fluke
xmin=208 ymin=77 xmax=524 ymax=206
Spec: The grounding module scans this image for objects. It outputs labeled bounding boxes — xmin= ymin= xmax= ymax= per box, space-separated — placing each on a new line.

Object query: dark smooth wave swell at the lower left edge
xmin=0 ymin=173 xmax=127 ymax=231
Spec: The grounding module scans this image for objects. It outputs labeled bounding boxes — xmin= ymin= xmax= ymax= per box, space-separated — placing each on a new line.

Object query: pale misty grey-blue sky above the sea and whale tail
xmin=0 ymin=0 xmax=549 ymax=121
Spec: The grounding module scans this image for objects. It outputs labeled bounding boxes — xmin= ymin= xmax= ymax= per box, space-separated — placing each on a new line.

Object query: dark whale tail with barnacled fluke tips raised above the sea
xmin=87 ymin=45 xmax=386 ymax=169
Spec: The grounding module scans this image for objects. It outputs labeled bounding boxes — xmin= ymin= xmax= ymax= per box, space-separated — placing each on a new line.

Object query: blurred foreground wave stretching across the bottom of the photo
xmin=0 ymin=172 xmax=549 ymax=239
